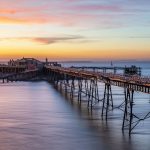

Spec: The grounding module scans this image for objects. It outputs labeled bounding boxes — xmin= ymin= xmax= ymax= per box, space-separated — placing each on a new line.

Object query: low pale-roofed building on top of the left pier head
xmin=8 ymin=57 xmax=44 ymax=70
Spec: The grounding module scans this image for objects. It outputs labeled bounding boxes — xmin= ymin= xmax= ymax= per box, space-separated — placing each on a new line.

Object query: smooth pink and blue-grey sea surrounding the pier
xmin=0 ymin=61 xmax=150 ymax=150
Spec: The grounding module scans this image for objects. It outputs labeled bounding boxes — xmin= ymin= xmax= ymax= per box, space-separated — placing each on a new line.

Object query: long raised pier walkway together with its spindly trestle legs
xmin=45 ymin=66 xmax=150 ymax=134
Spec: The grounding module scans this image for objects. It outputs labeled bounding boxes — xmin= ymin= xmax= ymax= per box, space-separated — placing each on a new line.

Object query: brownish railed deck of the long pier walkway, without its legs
xmin=46 ymin=66 xmax=150 ymax=94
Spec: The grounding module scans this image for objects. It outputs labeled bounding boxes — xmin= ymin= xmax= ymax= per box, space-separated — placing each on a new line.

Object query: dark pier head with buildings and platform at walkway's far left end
xmin=0 ymin=57 xmax=61 ymax=83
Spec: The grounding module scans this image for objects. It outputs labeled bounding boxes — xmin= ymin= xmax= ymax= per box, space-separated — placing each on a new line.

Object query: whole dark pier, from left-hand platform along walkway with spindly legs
xmin=0 ymin=60 xmax=150 ymax=135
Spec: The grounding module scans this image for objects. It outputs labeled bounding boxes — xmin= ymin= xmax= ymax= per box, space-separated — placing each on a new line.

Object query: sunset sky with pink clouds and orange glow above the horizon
xmin=0 ymin=0 xmax=150 ymax=60
